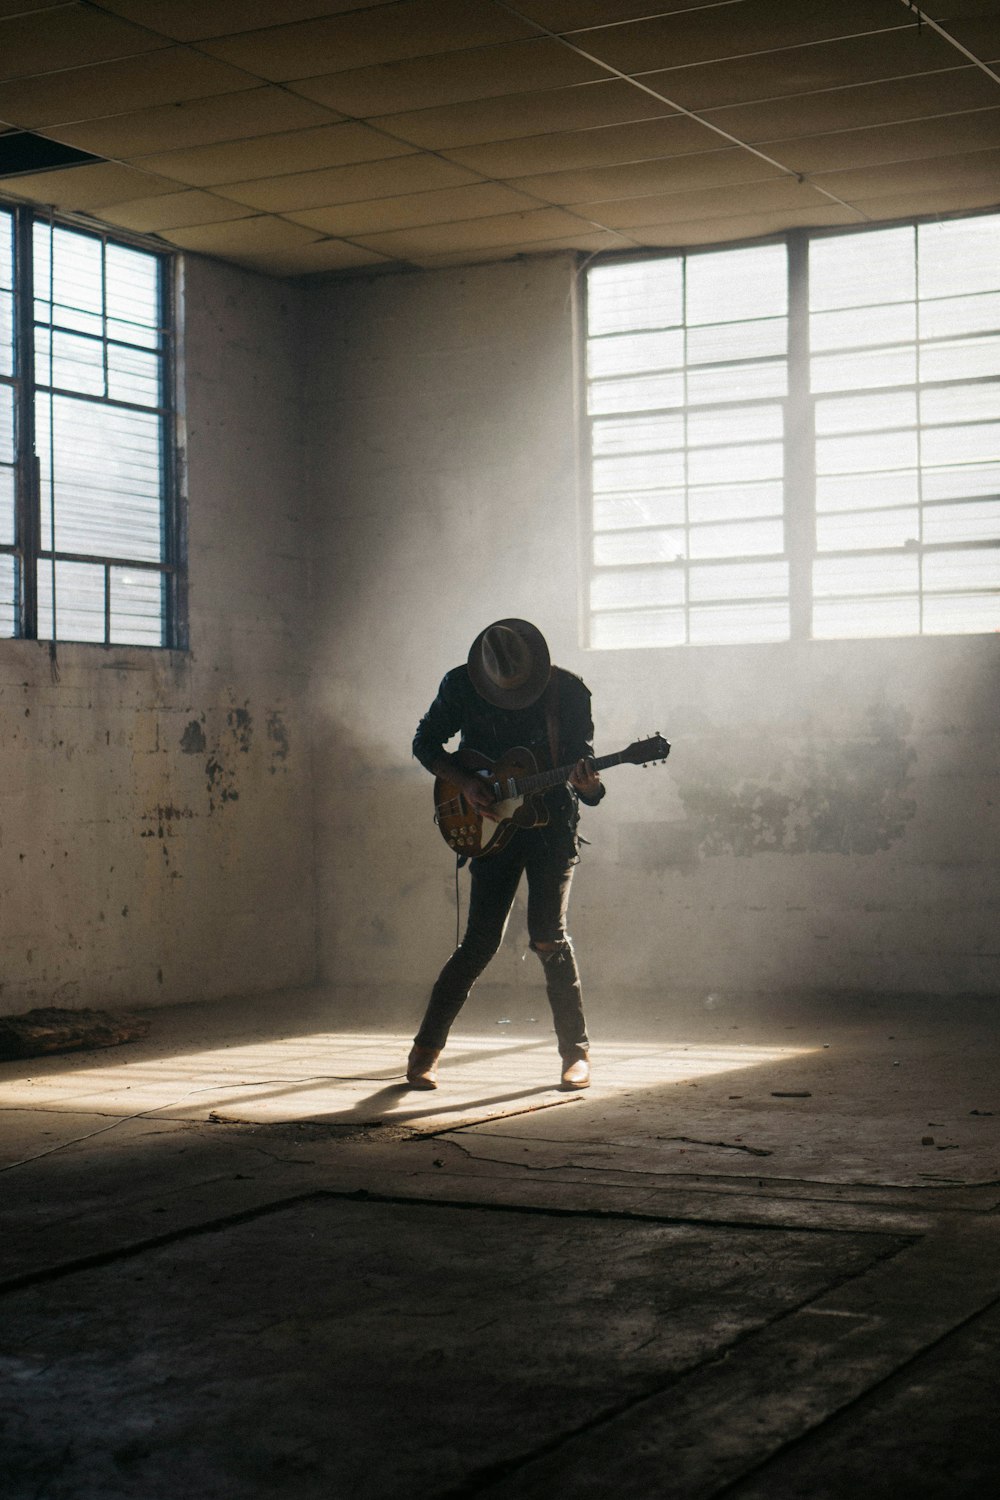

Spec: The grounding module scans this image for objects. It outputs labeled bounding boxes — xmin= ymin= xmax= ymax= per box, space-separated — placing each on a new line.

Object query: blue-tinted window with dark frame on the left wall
xmin=0 ymin=207 xmax=181 ymax=647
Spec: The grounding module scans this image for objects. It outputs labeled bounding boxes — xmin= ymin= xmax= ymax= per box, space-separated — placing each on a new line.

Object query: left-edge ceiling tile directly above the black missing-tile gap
xmin=0 ymin=47 xmax=257 ymax=129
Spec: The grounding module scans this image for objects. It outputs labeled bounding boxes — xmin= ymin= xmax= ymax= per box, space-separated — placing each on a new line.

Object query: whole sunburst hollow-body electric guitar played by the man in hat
xmin=433 ymin=735 xmax=670 ymax=860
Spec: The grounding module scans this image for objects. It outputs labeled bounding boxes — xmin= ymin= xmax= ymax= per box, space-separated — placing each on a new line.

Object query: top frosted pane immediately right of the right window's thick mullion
xmin=810 ymin=227 xmax=916 ymax=309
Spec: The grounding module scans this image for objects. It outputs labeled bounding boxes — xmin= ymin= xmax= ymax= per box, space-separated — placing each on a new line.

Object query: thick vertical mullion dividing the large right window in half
xmin=784 ymin=230 xmax=816 ymax=641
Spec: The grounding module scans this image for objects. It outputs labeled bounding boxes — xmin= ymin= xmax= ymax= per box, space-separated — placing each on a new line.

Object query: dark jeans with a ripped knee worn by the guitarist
xmin=414 ymin=825 xmax=588 ymax=1058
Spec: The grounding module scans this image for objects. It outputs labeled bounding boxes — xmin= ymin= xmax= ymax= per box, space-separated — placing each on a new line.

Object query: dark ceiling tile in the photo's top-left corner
xmin=0 ymin=5 xmax=166 ymax=80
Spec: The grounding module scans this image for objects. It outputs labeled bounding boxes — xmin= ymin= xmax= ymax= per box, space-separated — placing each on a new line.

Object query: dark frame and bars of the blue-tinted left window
xmin=0 ymin=197 xmax=189 ymax=651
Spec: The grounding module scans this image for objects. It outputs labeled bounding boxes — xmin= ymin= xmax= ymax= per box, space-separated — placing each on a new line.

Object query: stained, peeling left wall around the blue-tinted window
xmin=0 ymin=260 xmax=315 ymax=1014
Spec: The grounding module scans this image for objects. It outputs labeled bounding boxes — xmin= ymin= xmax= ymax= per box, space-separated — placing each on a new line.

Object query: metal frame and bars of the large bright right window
xmin=577 ymin=207 xmax=1000 ymax=651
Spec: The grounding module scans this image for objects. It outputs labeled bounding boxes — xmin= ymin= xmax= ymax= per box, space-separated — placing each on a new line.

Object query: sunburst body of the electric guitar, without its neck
xmin=433 ymin=746 xmax=549 ymax=860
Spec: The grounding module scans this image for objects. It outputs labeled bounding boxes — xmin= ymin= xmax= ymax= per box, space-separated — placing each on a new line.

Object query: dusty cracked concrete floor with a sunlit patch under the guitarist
xmin=0 ymin=987 xmax=1000 ymax=1500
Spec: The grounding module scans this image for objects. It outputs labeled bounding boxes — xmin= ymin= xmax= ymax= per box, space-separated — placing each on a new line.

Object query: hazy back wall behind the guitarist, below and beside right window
xmin=307 ymin=257 xmax=1000 ymax=1004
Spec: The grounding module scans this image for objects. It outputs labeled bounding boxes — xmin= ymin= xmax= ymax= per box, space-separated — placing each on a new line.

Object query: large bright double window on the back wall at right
xmin=586 ymin=215 xmax=1000 ymax=647
